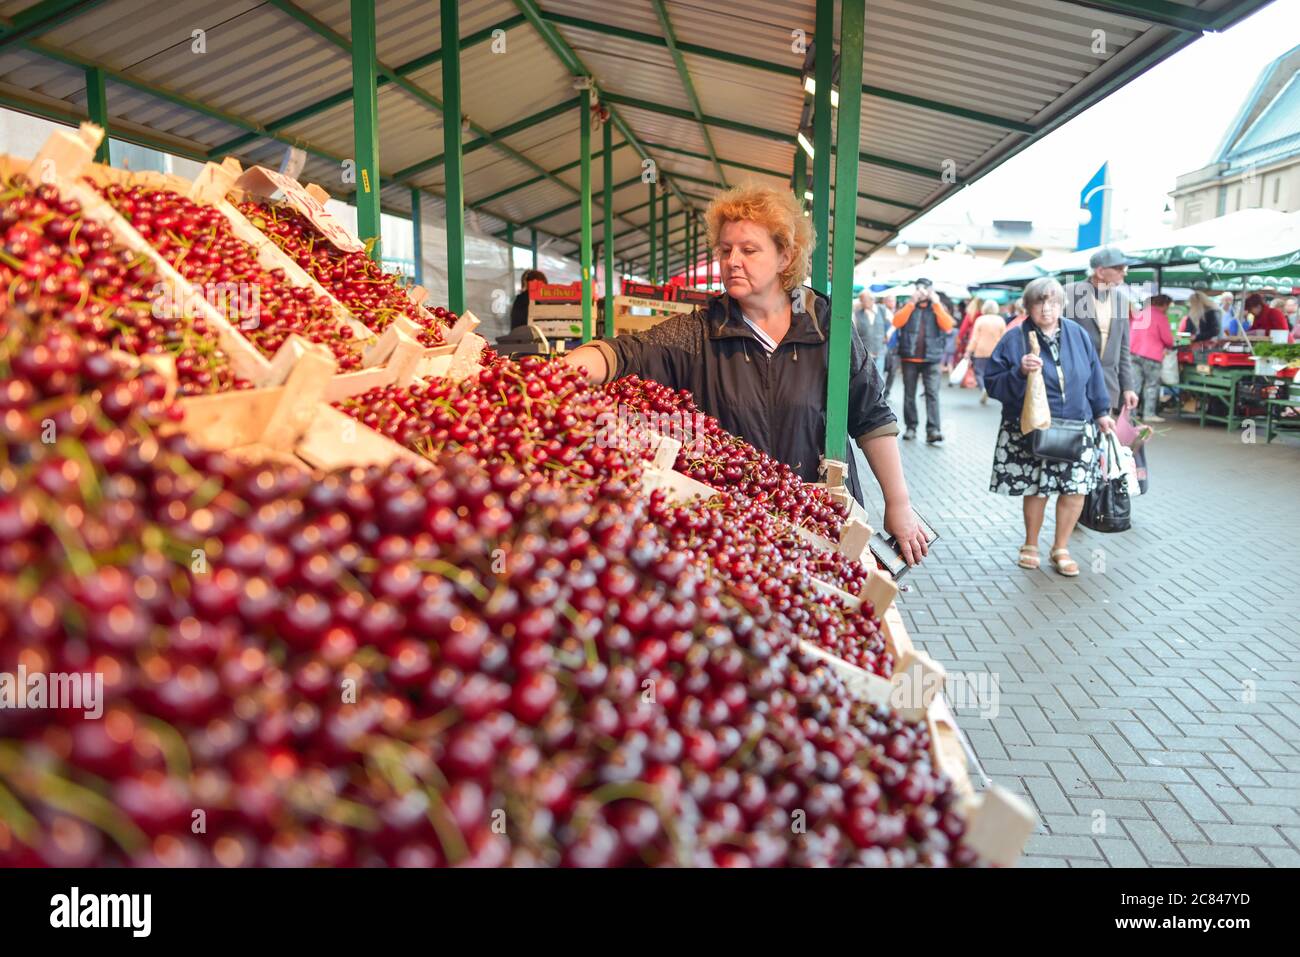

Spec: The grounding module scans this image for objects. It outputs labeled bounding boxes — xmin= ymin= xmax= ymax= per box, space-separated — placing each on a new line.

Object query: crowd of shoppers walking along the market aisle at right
xmin=854 ymin=247 xmax=1300 ymax=577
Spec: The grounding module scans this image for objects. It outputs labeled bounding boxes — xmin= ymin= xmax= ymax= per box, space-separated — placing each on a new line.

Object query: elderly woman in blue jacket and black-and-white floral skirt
xmin=984 ymin=277 xmax=1115 ymax=577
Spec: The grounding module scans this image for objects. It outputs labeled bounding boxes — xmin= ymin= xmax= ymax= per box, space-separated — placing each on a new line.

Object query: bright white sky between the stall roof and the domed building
xmin=904 ymin=0 xmax=1300 ymax=243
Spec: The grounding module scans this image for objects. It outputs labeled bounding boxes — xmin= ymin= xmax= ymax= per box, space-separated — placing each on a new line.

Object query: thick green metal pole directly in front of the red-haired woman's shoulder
xmin=818 ymin=0 xmax=866 ymax=460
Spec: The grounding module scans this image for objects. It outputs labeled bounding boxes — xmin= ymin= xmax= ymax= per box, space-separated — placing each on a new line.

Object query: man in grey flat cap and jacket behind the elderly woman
xmin=1065 ymin=246 xmax=1138 ymax=413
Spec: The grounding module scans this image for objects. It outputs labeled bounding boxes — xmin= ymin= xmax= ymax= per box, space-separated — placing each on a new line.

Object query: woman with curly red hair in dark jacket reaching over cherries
xmin=566 ymin=186 xmax=927 ymax=564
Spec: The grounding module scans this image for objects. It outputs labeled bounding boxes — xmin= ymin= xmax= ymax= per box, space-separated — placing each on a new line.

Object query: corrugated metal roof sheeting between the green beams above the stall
xmin=0 ymin=0 xmax=1268 ymax=265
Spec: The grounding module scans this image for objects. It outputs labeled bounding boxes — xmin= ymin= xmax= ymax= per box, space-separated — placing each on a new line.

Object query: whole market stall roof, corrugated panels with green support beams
xmin=0 ymin=0 xmax=1265 ymax=272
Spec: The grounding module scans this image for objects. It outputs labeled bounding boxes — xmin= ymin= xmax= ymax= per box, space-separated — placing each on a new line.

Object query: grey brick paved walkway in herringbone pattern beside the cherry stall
xmin=852 ymin=384 xmax=1300 ymax=867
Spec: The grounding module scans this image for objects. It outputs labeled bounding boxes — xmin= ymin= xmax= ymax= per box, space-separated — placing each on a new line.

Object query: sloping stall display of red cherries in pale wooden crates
xmin=0 ymin=125 xmax=1034 ymax=866
